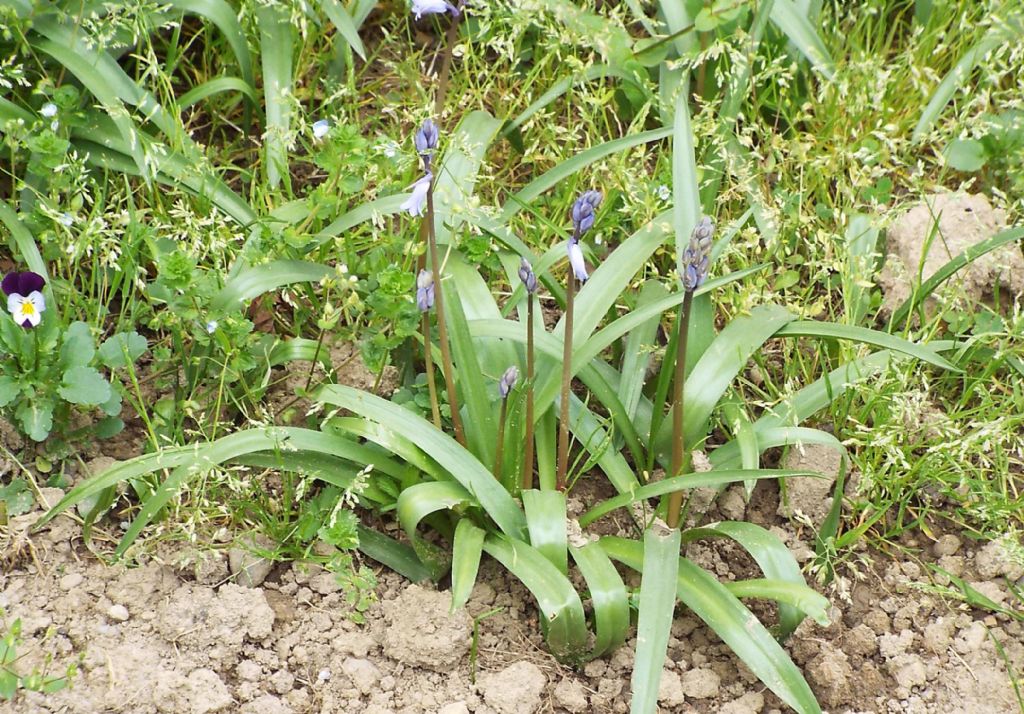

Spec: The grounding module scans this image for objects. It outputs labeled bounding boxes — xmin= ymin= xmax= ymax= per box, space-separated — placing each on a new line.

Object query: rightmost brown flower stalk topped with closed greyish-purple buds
xmin=667 ymin=216 xmax=715 ymax=528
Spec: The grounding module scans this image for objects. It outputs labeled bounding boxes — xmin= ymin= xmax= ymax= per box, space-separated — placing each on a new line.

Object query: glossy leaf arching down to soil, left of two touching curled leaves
xmin=483 ymin=534 xmax=588 ymax=663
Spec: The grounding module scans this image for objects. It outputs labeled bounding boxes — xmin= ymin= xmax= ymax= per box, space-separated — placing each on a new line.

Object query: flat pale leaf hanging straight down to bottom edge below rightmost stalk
xmin=630 ymin=527 xmax=680 ymax=714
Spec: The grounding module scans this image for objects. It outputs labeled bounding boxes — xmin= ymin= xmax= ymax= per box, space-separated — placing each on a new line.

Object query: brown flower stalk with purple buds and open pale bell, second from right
xmin=555 ymin=191 xmax=604 ymax=491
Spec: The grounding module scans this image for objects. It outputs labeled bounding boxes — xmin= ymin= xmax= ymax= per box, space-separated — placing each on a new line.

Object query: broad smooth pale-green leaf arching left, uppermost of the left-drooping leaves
xmin=316 ymin=384 xmax=526 ymax=539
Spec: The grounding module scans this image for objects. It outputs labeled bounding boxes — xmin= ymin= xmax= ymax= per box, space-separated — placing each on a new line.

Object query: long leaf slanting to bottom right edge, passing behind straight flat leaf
xmin=600 ymin=538 xmax=821 ymax=714
